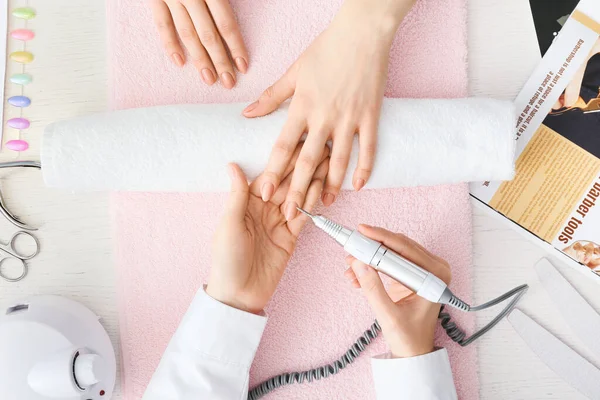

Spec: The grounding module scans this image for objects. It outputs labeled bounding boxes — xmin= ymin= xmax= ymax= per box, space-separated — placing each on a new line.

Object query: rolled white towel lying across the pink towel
xmin=41 ymin=98 xmax=515 ymax=192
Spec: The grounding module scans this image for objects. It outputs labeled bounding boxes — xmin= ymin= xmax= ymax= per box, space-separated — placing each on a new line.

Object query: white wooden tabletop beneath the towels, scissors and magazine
xmin=0 ymin=0 xmax=600 ymax=400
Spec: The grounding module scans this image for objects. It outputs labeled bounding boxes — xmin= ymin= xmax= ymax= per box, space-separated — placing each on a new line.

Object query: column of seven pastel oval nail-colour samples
xmin=6 ymin=7 xmax=36 ymax=151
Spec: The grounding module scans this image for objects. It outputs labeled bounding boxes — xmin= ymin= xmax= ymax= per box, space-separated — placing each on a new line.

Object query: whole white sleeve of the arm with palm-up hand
xmin=143 ymin=289 xmax=267 ymax=400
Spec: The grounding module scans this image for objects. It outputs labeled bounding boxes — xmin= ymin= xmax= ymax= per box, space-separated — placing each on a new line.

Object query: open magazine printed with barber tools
xmin=471 ymin=0 xmax=600 ymax=275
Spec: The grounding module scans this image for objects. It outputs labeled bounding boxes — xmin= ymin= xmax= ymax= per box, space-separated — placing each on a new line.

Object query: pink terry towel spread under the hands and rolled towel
xmin=108 ymin=0 xmax=478 ymax=400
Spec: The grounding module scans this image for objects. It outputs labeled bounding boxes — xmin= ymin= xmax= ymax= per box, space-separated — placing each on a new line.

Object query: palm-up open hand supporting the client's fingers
xmin=206 ymin=148 xmax=329 ymax=313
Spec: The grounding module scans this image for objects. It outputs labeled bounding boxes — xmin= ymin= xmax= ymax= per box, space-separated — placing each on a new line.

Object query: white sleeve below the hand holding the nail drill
xmin=371 ymin=349 xmax=457 ymax=400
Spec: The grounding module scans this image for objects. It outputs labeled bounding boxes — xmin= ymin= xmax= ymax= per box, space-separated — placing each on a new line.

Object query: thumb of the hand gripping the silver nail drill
xmin=352 ymin=260 xmax=396 ymax=321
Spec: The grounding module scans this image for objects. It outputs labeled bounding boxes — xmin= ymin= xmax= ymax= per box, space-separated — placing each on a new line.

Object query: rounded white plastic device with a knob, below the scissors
xmin=0 ymin=296 xmax=117 ymax=400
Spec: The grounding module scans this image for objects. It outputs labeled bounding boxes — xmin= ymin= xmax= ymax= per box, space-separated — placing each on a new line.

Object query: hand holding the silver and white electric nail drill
xmin=345 ymin=225 xmax=450 ymax=358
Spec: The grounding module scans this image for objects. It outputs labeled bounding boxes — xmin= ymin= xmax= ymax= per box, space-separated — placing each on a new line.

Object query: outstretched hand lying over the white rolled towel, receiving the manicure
xmin=244 ymin=0 xmax=414 ymax=220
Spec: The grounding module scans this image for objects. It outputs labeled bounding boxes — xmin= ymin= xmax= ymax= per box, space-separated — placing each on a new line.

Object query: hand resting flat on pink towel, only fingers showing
xmin=149 ymin=0 xmax=248 ymax=89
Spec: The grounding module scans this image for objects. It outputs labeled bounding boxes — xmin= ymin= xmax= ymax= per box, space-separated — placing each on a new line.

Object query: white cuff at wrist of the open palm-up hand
xmin=173 ymin=289 xmax=267 ymax=369
